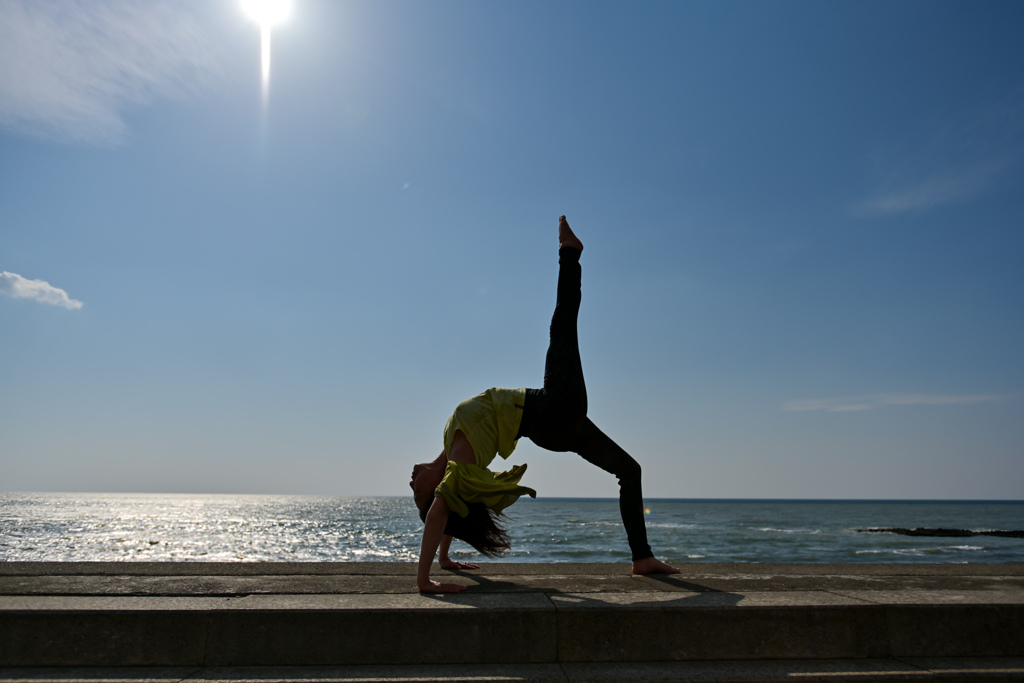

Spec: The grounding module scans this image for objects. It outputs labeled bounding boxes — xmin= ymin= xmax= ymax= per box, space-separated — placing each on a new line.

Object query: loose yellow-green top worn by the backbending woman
xmin=434 ymin=387 xmax=537 ymax=517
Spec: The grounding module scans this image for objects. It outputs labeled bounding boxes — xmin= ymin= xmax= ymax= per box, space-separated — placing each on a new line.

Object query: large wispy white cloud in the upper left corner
xmin=0 ymin=0 xmax=222 ymax=144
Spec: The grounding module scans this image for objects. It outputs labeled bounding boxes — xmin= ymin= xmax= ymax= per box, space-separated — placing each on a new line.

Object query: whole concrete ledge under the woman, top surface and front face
xmin=0 ymin=563 xmax=1024 ymax=667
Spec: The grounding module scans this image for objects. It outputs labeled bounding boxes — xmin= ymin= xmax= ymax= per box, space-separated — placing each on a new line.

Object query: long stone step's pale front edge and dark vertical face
xmin=0 ymin=591 xmax=1024 ymax=667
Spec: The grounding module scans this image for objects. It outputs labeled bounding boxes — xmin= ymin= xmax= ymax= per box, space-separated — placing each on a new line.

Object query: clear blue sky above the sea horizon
xmin=0 ymin=0 xmax=1024 ymax=499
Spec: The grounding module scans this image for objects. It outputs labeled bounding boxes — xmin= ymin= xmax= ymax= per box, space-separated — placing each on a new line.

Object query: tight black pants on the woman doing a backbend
xmin=519 ymin=248 xmax=654 ymax=561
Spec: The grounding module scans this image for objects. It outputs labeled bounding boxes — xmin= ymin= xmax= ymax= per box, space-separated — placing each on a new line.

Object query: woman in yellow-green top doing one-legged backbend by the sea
xmin=409 ymin=216 xmax=679 ymax=593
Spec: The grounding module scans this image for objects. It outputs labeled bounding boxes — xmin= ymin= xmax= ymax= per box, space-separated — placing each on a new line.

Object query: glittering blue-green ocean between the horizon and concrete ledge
xmin=0 ymin=494 xmax=1024 ymax=562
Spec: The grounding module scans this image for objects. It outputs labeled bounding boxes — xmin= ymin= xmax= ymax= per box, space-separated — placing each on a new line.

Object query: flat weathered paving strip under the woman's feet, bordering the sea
xmin=6 ymin=562 xmax=1024 ymax=595
